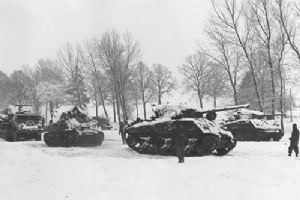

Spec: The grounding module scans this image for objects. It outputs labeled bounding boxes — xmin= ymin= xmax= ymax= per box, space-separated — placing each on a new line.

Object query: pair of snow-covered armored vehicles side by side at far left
xmin=0 ymin=105 xmax=105 ymax=147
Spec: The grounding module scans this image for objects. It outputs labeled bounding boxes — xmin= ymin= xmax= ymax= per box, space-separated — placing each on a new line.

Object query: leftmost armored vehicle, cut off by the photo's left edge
xmin=0 ymin=105 xmax=44 ymax=142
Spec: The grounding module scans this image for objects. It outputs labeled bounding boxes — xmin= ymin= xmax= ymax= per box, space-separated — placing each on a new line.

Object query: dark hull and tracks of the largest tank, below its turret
xmin=125 ymin=119 xmax=236 ymax=156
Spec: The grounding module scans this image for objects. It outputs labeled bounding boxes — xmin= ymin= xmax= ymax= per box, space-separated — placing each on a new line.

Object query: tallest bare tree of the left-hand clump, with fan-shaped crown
xmin=98 ymin=31 xmax=140 ymax=121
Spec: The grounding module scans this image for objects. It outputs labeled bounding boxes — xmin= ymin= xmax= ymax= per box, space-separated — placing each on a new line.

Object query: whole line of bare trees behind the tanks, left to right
xmin=0 ymin=0 xmax=300 ymax=121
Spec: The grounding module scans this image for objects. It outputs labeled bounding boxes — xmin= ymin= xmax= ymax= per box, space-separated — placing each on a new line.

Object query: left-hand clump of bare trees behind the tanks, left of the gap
xmin=0 ymin=30 xmax=175 ymax=122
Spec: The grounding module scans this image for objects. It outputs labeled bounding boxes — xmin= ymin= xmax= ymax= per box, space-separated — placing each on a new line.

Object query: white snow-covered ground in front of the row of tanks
xmin=0 ymin=120 xmax=300 ymax=200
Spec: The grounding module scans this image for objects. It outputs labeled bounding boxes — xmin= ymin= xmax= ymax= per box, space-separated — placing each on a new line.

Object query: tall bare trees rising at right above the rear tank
xmin=194 ymin=0 xmax=300 ymax=117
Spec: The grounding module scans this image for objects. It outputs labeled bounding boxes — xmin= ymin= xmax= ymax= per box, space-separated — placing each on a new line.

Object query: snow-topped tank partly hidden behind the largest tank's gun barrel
xmin=223 ymin=109 xmax=284 ymax=141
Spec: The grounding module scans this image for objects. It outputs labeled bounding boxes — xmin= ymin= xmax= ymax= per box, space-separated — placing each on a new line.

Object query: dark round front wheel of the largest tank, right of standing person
xmin=196 ymin=135 xmax=219 ymax=156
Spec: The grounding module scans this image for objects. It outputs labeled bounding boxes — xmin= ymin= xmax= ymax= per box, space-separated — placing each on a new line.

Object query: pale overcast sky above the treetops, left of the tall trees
xmin=0 ymin=0 xmax=210 ymax=74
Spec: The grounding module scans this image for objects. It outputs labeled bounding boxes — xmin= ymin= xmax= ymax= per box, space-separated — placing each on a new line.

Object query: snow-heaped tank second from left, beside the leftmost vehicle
xmin=44 ymin=106 xmax=104 ymax=147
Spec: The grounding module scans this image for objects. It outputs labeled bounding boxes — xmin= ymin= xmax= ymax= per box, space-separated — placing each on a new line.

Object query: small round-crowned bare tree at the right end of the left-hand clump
xmin=151 ymin=64 xmax=175 ymax=105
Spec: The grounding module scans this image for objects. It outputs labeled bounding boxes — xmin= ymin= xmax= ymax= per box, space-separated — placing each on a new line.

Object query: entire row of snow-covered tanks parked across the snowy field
xmin=0 ymin=105 xmax=283 ymax=159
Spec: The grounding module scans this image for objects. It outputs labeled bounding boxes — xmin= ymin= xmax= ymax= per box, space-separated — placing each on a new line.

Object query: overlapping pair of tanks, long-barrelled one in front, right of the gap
xmin=125 ymin=104 xmax=284 ymax=156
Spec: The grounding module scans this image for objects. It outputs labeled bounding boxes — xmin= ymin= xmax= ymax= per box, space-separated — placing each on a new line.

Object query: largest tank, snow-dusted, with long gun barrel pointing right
xmin=125 ymin=105 xmax=250 ymax=156
